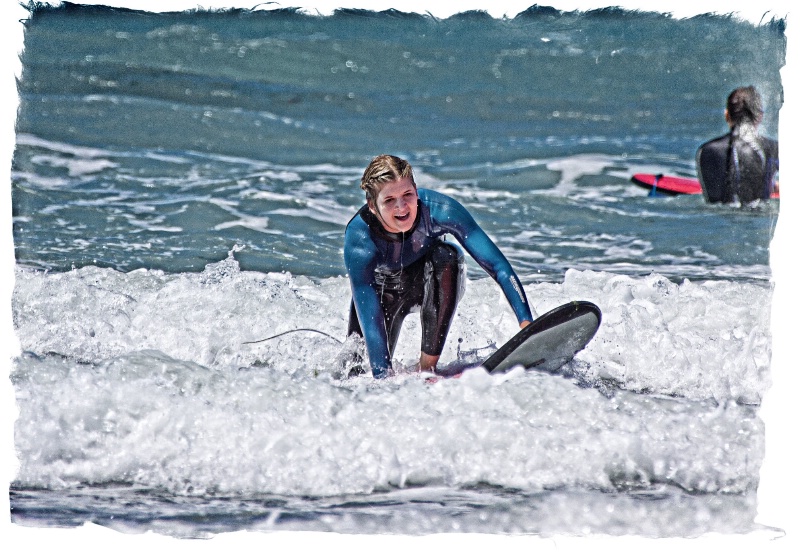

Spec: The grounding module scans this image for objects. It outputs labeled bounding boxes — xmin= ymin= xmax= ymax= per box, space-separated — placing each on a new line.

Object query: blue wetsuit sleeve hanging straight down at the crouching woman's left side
xmin=344 ymin=219 xmax=392 ymax=378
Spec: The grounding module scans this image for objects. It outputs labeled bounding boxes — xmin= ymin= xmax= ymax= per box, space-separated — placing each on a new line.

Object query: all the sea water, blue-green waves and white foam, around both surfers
xmin=3 ymin=0 xmax=786 ymax=538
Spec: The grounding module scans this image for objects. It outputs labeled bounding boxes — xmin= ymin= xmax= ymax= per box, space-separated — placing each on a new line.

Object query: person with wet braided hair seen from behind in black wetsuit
xmin=696 ymin=86 xmax=778 ymax=205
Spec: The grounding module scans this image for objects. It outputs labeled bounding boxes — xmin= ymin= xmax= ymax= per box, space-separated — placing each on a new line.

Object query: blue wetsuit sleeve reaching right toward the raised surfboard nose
xmin=428 ymin=195 xmax=533 ymax=323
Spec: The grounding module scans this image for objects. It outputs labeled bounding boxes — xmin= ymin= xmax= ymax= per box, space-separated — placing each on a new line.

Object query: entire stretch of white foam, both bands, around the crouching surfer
xmin=12 ymin=256 xmax=771 ymax=508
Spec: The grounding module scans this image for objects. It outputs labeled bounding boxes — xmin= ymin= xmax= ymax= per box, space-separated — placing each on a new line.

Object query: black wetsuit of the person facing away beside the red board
xmin=696 ymin=130 xmax=778 ymax=204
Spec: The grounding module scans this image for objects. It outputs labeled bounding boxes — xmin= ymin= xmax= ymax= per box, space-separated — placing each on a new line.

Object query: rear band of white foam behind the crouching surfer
xmin=14 ymin=252 xmax=771 ymax=403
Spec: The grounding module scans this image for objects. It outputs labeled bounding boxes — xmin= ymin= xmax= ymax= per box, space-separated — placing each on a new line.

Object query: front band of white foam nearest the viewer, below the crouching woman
xmin=9 ymin=349 xmax=763 ymax=495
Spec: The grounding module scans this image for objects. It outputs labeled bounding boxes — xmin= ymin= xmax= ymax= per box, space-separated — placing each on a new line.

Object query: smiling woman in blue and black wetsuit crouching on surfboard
xmin=344 ymin=155 xmax=533 ymax=378
